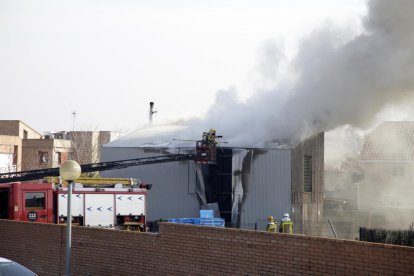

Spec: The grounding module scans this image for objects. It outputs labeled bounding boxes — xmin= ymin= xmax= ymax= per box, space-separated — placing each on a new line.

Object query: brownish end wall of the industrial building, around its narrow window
xmin=292 ymin=133 xmax=324 ymax=235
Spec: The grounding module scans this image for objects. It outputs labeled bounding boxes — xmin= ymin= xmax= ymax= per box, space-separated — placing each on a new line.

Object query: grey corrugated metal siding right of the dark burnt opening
xmin=236 ymin=149 xmax=291 ymax=230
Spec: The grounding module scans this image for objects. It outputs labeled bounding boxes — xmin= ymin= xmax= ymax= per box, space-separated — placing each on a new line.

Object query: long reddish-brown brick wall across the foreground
xmin=0 ymin=220 xmax=414 ymax=275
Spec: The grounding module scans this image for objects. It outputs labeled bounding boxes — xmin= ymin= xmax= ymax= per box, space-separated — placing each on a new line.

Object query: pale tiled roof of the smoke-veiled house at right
xmin=360 ymin=122 xmax=414 ymax=160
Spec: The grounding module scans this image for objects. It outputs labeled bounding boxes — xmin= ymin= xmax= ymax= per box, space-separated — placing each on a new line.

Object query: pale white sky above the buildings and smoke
xmin=0 ymin=0 xmax=366 ymax=132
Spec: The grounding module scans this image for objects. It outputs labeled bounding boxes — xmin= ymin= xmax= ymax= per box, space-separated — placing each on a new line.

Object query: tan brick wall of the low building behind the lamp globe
xmin=22 ymin=139 xmax=72 ymax=170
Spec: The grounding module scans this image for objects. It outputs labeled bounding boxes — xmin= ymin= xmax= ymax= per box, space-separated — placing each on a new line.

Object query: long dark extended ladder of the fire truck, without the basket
xmin=0 ymin=154 xmax=194 ymax=183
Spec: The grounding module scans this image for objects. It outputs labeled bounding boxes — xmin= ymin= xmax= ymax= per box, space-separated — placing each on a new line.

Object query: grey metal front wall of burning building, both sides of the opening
xmin=101 ymin=147 xmax=291 ymax=226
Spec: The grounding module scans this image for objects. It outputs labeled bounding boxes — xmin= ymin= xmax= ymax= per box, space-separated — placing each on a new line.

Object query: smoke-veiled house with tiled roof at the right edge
xmin=359 ymin=122 xmax=414 ymax=228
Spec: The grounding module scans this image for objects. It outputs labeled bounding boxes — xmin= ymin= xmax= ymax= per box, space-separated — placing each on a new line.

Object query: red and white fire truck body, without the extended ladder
xmin=0 ymin=179 xmax=149 ymax=231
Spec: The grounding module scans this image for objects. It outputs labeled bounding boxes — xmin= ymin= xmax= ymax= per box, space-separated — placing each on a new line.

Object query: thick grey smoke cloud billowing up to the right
xmin=186 ymin=0 xmax=414 ymax=145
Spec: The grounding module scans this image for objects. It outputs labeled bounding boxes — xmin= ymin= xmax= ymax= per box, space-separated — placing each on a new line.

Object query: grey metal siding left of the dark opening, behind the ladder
xmin=102 ymin=147 xmax=200 ymax=221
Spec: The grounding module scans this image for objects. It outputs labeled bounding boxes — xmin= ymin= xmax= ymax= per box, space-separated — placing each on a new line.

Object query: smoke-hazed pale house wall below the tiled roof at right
xmin=357 ymin=160 xmax=414 ymax=229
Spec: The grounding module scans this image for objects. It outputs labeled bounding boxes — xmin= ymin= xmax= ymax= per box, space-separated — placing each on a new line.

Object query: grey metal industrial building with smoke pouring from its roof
xmin=102 ymin=126 xmax=324 ymax=234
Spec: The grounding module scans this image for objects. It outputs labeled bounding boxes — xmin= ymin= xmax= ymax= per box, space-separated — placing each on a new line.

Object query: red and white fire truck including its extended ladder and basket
xmin=0 ymin=129 xmax=220 ymax=231
